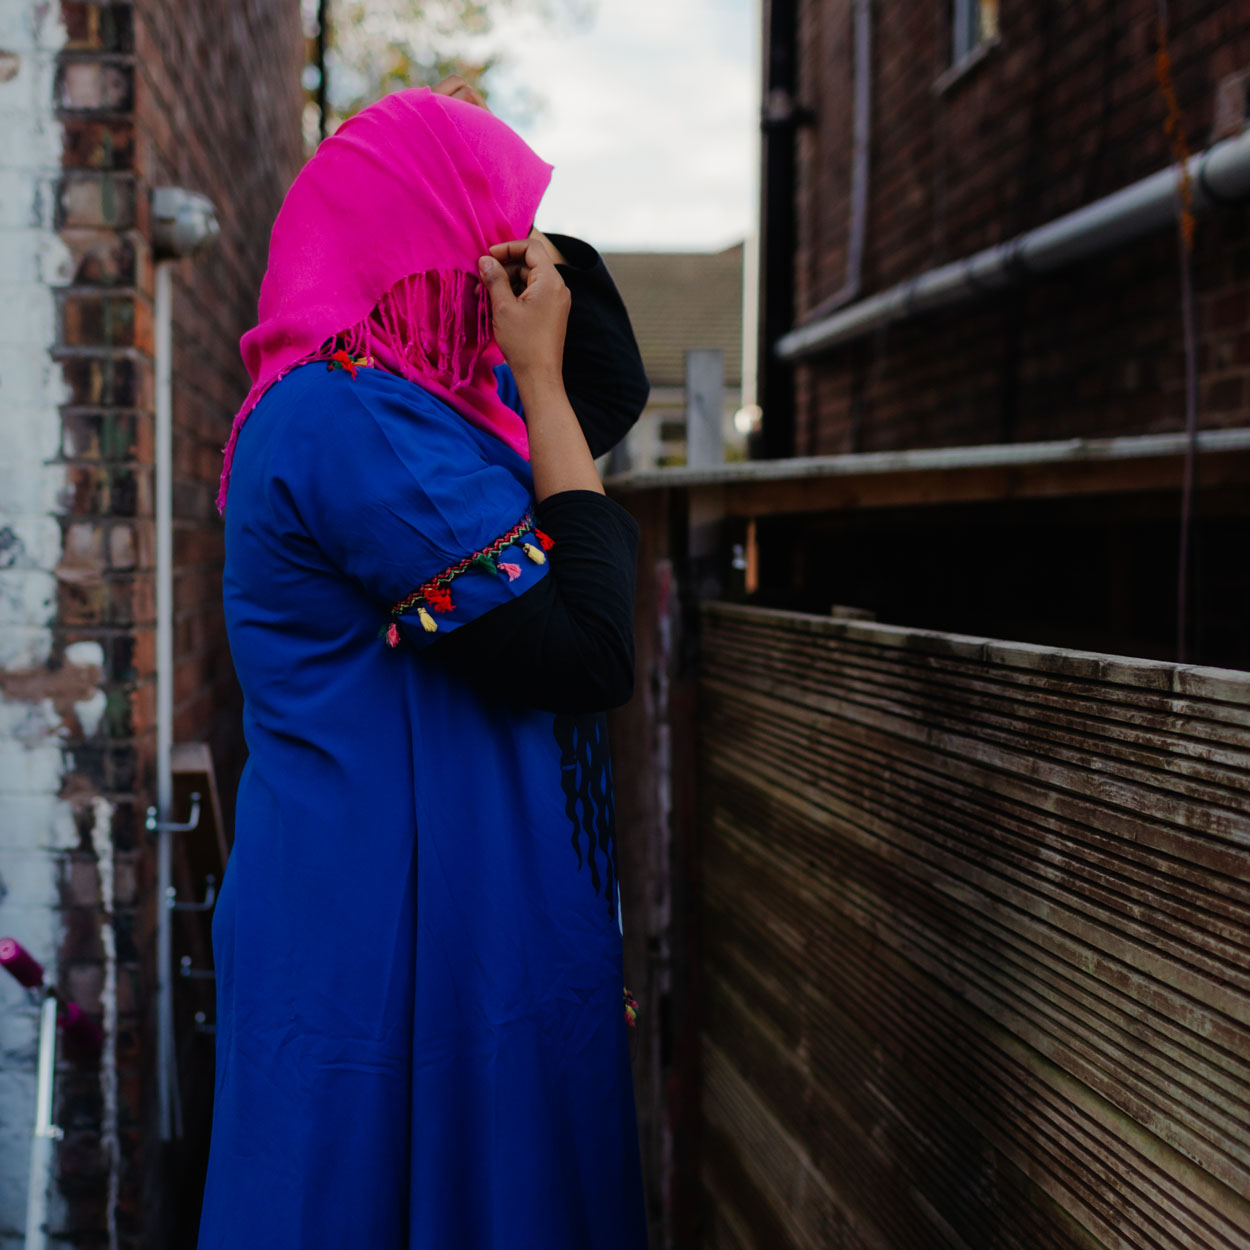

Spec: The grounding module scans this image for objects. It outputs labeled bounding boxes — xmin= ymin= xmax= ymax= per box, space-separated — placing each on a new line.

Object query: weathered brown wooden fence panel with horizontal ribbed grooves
xmin=699 ymin=604 xmax=1250 ymax=1250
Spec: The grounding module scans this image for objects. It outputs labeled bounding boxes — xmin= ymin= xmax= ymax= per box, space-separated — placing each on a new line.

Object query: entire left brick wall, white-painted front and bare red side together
xmin=0 ymin=0 xmax=304 ymax=1250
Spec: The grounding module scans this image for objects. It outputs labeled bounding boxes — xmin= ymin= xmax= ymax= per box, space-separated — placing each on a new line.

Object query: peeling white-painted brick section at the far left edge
xmin=0 ymin=0 xmax=78 ymax=1250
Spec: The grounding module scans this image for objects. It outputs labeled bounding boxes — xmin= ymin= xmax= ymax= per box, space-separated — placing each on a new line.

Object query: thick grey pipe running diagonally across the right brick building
xmin=774 ymin=123 xmax=1250 ymax=361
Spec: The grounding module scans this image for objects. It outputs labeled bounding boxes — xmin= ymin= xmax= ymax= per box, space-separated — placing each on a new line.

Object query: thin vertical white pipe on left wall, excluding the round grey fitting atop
xmin=154 ymin=260 xmax=181 ymax=1141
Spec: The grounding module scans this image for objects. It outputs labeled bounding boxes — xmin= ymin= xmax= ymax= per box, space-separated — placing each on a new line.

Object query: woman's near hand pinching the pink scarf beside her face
xmin=478 ymin=238 xmax=573 ymax=381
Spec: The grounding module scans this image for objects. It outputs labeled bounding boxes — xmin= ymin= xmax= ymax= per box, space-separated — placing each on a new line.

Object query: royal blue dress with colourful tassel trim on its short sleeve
xmin=199 ymin=364 xmax=646 ymax=1250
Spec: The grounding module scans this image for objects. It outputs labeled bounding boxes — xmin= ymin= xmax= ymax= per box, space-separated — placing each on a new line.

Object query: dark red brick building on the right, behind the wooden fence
xmin=761 ymin=0 xmax=1250 ymax=666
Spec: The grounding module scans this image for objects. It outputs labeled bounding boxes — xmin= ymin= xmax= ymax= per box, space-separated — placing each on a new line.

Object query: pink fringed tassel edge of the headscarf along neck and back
xmin=218 ymin=269 xmax=493 ymax=513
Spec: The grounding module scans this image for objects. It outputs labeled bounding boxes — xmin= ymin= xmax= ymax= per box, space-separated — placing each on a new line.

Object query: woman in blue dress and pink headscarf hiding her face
xmin=199 ymin=84 xmax=646 ymax=1250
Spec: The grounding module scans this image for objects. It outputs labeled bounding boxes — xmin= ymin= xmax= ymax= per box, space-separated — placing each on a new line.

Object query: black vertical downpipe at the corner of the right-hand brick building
xmin=753 ymin=0 xmax=808 ymax=460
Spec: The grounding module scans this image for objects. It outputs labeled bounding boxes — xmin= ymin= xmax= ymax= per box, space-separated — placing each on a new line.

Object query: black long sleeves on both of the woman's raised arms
xmin=430 ymin=235 xmax=650 ymax=713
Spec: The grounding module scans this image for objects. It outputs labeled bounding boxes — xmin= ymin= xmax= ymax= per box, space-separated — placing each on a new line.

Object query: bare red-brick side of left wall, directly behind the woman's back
xmin=134 ymin=0 xmax=304 ymax=804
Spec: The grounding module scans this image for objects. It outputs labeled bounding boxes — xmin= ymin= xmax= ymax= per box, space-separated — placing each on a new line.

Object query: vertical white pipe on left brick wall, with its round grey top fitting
xmin=148 ymin=186 xmax=220 ymax=1141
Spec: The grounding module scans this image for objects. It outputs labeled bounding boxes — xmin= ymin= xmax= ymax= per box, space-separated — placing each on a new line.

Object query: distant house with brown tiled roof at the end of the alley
xmin=604 ymin=244 xmax=744 ymax=469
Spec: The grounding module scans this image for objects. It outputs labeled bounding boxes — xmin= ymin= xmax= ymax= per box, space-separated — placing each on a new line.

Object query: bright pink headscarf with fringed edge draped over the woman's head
xmin=218 ymin=88 xmax=551 ymax=509
